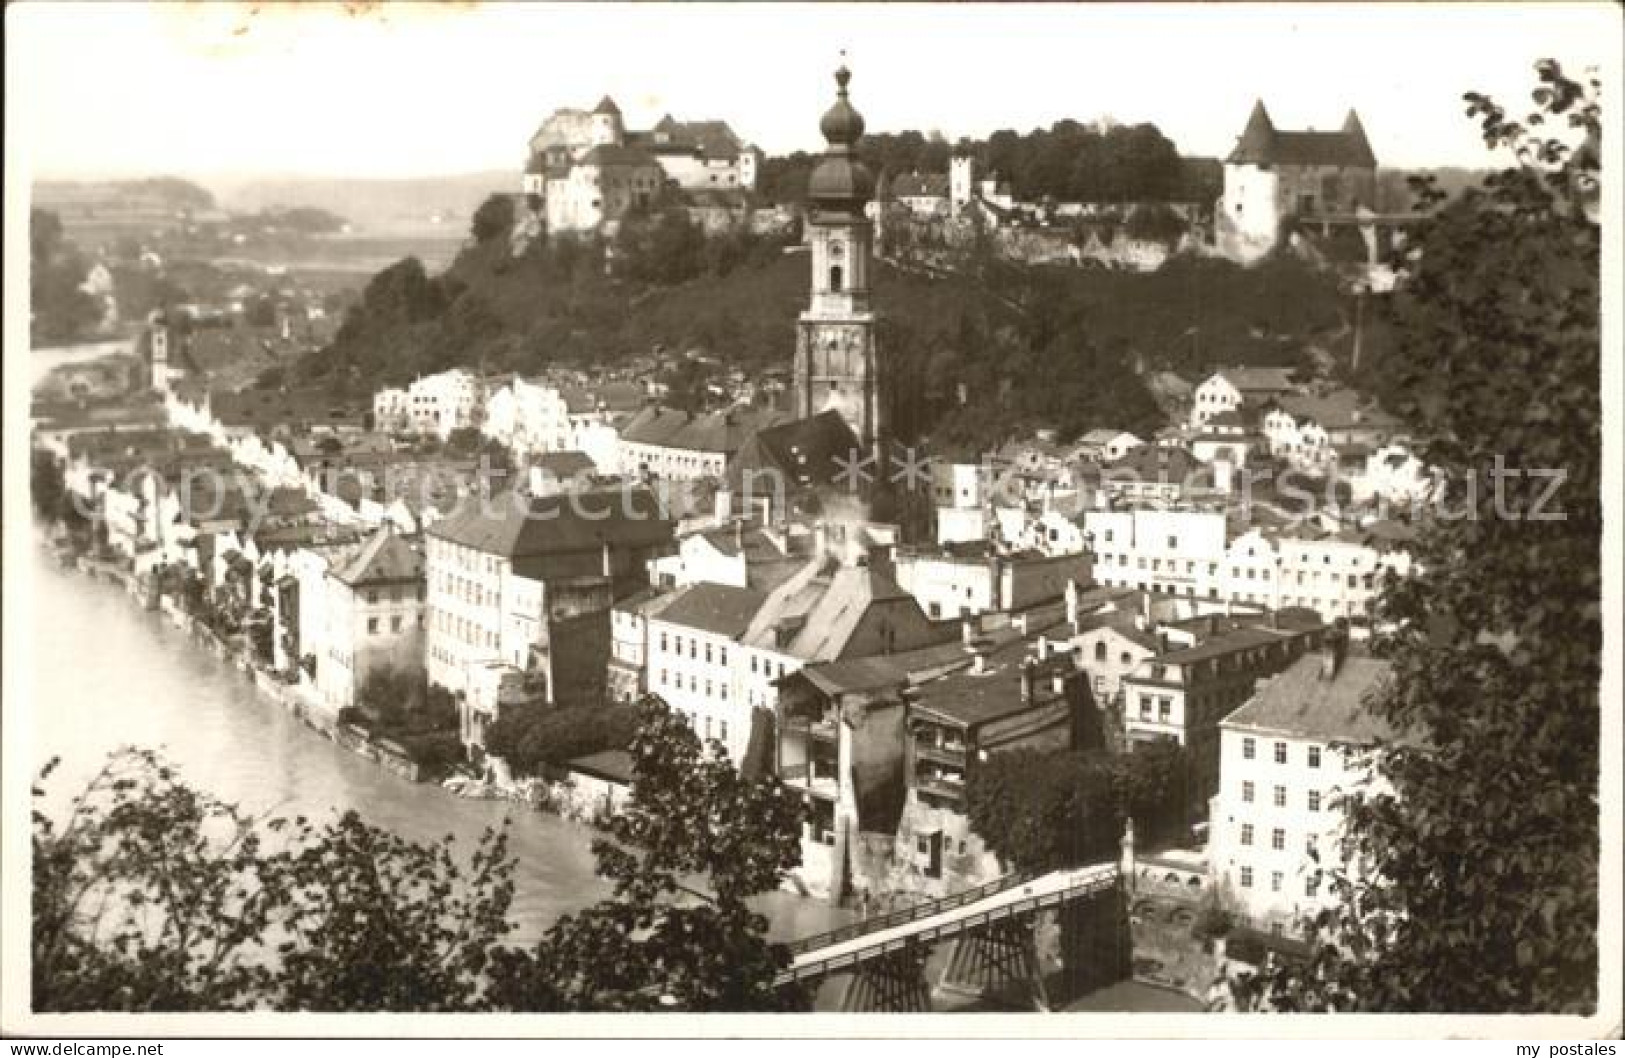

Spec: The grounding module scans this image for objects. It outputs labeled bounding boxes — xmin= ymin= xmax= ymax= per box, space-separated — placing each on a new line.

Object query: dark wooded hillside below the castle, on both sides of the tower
xmin=286 ymin=207 xmax=1347 ymax=445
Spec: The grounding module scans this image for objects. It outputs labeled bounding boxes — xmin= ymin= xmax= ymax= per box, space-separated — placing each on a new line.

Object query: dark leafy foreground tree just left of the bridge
xmin=491 ymin=697 xmax=806 ymax=1011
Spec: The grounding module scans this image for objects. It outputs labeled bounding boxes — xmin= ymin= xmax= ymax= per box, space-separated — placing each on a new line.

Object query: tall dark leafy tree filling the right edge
xmin=1240 ymin=60 xmax=1602 ymax=1012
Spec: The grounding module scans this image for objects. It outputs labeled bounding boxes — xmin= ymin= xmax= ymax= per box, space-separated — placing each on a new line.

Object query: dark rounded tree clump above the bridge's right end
xmin=965 ymin=743 xmax=1185 ymax=871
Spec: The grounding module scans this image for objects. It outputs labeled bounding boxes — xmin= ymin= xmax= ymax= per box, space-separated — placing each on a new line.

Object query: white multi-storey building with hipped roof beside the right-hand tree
xmin=1209 ymin=647 xmax=1389 ymax=933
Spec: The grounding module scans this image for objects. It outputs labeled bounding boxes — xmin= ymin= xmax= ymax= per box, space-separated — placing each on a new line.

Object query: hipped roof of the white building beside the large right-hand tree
xmin=1224 ymin=652 xmax=1393 ymax=743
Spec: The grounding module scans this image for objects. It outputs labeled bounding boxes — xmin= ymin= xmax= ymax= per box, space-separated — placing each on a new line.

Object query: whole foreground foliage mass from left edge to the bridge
xmin=33 ymin=699 xmax=804 ymax=1011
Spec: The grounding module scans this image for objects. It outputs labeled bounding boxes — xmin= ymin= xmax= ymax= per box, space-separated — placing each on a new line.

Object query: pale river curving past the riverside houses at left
xmin=25 ymin=546 xmax=850 ymax=943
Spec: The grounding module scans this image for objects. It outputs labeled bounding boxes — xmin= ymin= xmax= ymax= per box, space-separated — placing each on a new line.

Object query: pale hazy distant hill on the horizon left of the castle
xmin=210 ymin=169 xmax=518 ymax=232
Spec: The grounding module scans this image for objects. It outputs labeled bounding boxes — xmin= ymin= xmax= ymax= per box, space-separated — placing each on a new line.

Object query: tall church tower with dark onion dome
xmin=793 ymin=67 xmax=886 ymax=449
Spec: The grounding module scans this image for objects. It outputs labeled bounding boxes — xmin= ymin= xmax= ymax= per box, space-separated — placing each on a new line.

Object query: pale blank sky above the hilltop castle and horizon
xmin=7 ymin=3 xmax=1620 ymax=177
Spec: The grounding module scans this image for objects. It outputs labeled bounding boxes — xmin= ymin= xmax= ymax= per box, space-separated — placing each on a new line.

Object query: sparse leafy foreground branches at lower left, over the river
xmin=33 ymin=751 xmax=512 ymax=1011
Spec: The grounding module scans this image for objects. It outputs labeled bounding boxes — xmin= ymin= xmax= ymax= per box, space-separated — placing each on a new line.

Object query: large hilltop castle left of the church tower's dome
xmin=520 ymin=96 xmax=762 ymax=231
